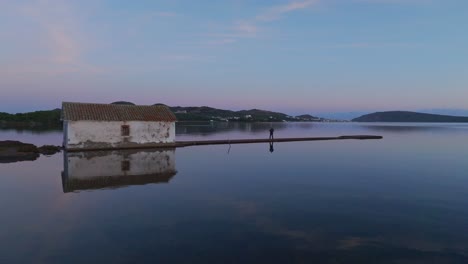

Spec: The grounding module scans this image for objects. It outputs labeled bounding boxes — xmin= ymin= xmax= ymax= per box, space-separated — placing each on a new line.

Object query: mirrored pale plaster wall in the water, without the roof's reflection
xmin=64 ymin=149 xmax=176 ymax=179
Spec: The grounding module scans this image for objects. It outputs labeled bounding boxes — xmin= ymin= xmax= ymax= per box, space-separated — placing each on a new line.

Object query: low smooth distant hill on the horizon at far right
xmin=352 ymin=111 xmax=468 ymax=123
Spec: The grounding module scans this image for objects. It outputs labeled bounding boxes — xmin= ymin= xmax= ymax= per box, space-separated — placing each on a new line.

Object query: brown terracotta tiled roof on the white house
xmin=62 ymin=102 xmax=177 ymax=122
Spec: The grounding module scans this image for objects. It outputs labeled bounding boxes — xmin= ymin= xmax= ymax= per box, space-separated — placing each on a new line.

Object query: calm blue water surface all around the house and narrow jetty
xmin=0 ymin=123 xmax=468 ymax=263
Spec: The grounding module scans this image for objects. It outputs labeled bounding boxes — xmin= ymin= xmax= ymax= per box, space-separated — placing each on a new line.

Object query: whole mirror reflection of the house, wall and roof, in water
xmin=62 ymin=148 xmax=177 ymax=193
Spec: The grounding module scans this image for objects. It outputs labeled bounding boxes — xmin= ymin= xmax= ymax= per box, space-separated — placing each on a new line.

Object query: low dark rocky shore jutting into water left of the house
xmin=0 ymin=140 xmax=62 ymax=163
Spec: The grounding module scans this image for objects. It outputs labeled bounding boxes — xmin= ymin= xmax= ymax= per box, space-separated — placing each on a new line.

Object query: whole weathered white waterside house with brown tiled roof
xmin=62 ymin=102 xmax=176 ymax=150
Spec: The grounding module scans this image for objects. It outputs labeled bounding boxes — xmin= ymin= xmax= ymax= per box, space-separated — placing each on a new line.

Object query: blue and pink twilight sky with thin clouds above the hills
xmin=0 ymin=0 xmax=468 ymax=114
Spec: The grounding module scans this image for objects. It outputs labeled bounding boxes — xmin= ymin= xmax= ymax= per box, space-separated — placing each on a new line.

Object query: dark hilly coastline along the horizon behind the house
xmin=0 ymin=101 xmax=468 ymax=130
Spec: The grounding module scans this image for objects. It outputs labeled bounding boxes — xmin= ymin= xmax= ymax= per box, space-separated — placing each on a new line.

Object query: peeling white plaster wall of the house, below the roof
xmin=65 ymin=121 xmax=175 ymax=149
